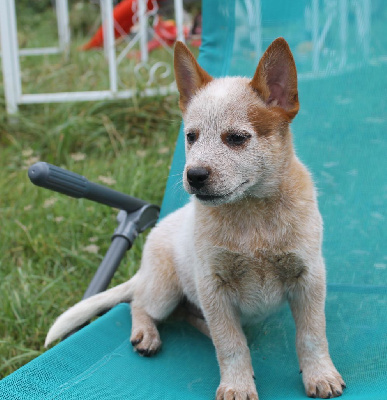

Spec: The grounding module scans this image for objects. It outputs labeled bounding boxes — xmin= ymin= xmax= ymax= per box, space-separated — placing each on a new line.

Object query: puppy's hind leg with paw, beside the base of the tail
xmin=130 ymin=231 xmax=182 ymax=357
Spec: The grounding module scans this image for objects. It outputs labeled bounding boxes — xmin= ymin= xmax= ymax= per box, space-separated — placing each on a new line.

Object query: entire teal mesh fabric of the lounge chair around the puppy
xmin=0 ymin=0 xmax=387 ymax=400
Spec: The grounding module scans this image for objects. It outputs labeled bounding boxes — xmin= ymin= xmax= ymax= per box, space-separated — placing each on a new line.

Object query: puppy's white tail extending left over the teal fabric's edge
xmin=44 ymin=275 xmax=137 ymax=347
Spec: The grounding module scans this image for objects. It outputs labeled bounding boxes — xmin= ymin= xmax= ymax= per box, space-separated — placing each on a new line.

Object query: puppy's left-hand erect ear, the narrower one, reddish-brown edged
xmin=174 ymin=42 xmax=212 ymax=112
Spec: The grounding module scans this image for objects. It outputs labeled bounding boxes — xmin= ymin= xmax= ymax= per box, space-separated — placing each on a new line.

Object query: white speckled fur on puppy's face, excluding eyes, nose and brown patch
xmin=183 ymin=77 xmax=288 ymax=201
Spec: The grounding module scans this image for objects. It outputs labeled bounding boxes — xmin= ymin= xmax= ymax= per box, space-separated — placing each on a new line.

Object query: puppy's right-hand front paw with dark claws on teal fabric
xmin=303 ymin=361 xmax=346 ymax=399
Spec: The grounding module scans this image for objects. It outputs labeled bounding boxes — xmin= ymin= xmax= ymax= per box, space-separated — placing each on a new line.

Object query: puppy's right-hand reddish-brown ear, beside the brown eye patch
xmin=250 ymin=38 xmax=300 ymax=120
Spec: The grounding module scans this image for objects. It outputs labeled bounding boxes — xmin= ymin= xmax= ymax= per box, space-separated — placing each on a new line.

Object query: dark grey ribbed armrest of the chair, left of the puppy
xmin=28 ymin=162 xmax=148 ymax=212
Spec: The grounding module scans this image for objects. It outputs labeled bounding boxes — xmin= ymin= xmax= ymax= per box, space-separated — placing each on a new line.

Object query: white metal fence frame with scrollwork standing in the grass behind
xmin=0 ymin=0 xmax=184 ymax=114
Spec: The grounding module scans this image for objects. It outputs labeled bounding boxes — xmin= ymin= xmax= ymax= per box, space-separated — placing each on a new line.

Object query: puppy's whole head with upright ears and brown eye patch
xmin=175 ymin=38 xmax=299 ymax=205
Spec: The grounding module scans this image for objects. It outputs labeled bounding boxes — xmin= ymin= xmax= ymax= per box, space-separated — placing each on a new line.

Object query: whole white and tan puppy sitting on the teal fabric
xmin=46 ymin=38 xmax=345 ymax=400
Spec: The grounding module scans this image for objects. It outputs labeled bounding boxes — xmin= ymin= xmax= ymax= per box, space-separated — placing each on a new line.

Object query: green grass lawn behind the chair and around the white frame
xmin=0 ymin=5 xmax=185 ymax=377
